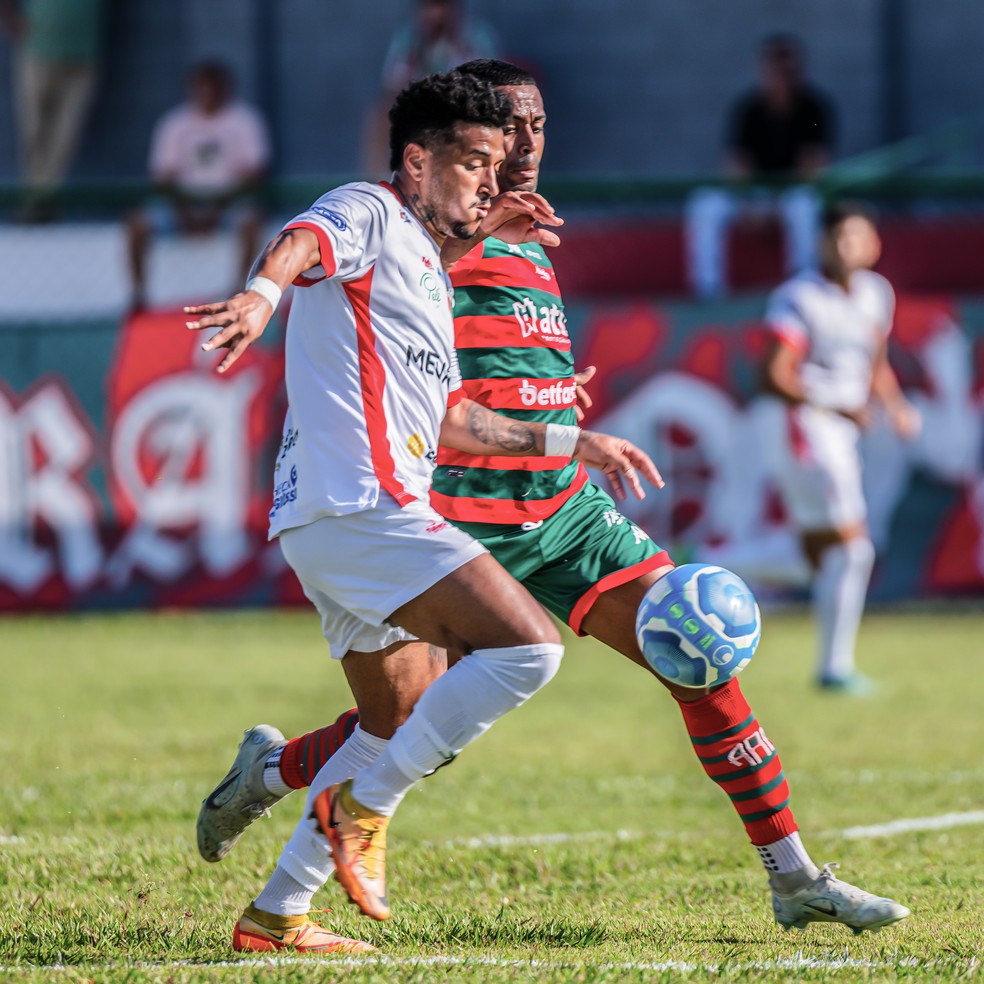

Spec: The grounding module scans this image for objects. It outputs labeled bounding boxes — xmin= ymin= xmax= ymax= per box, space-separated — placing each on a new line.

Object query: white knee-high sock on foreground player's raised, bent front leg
xmin=352 ymin=643 xmax=564 ymax=816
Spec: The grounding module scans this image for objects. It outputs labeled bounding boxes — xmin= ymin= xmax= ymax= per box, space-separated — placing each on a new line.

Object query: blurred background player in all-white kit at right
xmin=765 ymin=203 xmax=919 ymax=695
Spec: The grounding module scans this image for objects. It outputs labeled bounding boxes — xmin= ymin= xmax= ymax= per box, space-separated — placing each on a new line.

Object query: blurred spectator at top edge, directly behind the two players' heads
xmin=364 ymin=0 xmax=499 ymax=176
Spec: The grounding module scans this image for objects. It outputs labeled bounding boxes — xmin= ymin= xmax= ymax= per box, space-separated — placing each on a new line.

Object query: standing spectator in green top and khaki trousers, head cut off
xmin=0 ymin=0 xmax=104 ymax=222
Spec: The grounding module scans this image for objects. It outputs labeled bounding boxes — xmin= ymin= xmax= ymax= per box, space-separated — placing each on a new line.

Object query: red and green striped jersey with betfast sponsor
xmin=431 ymin=239 xmax=588 ymax=525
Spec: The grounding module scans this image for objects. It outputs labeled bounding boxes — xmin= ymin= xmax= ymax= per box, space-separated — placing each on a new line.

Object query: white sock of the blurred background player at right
xmin=813 ymin=537 xmax=875 ymax=680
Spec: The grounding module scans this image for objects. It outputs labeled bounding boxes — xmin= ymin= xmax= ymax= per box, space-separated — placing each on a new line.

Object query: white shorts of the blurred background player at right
xmin=777 ymin=404 xmax=867 ymax=530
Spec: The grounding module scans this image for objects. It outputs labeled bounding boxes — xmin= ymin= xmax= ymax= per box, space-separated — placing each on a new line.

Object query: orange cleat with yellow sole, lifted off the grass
xmin=314 ymin=779 xmax=390 ymax=920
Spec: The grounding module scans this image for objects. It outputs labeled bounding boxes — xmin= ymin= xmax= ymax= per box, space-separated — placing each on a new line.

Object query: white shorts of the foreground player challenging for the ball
xmin=279 ymin=493 xmax=488 ymax=659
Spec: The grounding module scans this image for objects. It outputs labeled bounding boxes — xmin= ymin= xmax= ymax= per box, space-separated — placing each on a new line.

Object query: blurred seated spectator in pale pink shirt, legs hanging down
xmin=127 ymin=62 xmax=270 ymax=308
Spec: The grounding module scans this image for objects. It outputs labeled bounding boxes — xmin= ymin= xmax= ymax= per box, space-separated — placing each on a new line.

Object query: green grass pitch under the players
xmin=0 ymin=611 xmax=984 ymax=981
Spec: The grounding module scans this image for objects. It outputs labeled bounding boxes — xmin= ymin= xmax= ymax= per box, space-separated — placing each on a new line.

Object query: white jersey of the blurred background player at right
xmin=765 ymin=270 xmax=895 ymax=410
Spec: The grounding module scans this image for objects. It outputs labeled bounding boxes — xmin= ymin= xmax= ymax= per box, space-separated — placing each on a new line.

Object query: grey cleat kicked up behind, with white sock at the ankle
xmin=197 ymin=724 xmax=287 ymax=861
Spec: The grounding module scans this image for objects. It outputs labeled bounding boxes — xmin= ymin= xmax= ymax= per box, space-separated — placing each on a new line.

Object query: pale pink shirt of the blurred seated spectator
xmin=150 ymin=103 xmax=270 ymax=194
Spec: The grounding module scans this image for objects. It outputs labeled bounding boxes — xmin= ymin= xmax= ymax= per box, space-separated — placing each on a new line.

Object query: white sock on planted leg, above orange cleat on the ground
xmin=274 ymin=725 xmax=388 ymax=900
